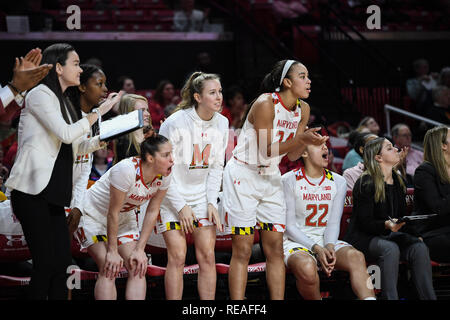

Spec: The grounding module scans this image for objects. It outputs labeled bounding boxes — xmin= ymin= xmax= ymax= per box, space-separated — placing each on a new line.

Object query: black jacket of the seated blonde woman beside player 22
xmin=344 ymin=175 xmax=415 ymax=255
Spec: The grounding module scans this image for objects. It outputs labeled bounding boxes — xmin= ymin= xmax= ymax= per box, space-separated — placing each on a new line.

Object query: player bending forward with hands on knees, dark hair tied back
xmin=76 ymin=135 xmax=173 ymax=300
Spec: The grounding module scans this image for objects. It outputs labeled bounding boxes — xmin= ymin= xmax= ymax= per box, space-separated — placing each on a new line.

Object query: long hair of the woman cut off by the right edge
xmin=423 ymin=126 xmax=450 ymax=183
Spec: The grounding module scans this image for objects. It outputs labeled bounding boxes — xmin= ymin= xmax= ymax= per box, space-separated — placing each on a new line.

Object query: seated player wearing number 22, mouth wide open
xmin=282 ymin=144 xmax=375 ymax=300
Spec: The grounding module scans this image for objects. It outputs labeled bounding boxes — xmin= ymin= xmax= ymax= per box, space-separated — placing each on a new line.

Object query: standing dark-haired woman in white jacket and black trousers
xmin=6 ymin=44 xmax=119 ymax=299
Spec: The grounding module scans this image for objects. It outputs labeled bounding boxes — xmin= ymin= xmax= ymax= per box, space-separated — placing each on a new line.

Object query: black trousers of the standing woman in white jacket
xmin=11 ymin=190 xmax=72 ymax=300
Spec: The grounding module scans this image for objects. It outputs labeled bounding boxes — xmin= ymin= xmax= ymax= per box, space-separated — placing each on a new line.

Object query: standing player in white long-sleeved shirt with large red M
xmin=158 ymin=72 xmax=228 ymax=300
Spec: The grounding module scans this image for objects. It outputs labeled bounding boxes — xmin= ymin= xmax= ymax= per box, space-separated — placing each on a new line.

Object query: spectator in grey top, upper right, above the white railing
xmin=406 ymin=59 xmax=437 ymax=111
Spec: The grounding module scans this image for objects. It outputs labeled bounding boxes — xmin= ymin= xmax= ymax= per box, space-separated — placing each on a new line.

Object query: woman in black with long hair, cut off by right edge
xmin=414 ymin=126 xmax=450 ymax=262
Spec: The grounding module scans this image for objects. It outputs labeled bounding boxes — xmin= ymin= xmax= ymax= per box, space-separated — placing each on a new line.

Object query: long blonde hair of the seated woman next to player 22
xmin=361 ymin=137 xmax=406 ymax=203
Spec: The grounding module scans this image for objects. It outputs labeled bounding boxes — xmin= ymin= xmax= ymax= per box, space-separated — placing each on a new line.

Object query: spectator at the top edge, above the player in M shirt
xmin=173 ymin=0 xmax=209 ymax=31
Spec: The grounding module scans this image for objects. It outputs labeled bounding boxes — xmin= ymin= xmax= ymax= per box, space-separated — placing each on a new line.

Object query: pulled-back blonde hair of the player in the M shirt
xmin=174 ymin=71 xmax=220 ymax=112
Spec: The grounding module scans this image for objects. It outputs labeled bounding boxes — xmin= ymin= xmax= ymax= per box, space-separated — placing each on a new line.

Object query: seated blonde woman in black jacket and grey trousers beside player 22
xmin=344 ymin=138 xmax=436 ymax=300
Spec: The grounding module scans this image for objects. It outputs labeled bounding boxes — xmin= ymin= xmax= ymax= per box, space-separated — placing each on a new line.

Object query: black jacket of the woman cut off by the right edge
xmin=414 ymin=162 xmax=450 ymax=237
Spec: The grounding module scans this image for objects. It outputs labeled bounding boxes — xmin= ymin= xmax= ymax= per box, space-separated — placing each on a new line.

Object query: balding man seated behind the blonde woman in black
xmin=391 ymin=123 xmax=423 ymax=187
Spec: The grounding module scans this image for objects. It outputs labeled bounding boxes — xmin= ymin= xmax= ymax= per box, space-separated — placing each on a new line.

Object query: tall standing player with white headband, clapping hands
xmin=223 ymin=60 xmax=327 ymax=299
